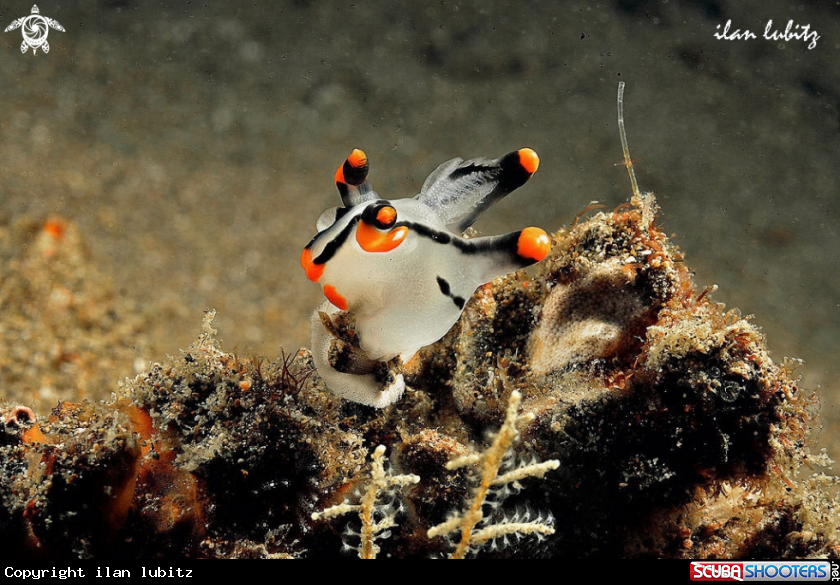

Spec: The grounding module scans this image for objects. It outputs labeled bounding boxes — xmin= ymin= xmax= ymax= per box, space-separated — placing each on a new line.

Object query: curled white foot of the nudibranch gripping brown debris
xmin=312 ymin=303 xmax=405 ymax=408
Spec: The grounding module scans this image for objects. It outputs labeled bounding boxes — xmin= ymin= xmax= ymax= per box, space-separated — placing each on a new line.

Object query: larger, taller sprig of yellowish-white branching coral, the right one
xmin=427 ymin=391 xmax=560 ymax=559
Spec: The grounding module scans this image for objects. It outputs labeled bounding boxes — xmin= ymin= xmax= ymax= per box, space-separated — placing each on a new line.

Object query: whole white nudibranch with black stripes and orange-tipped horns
xmin=300 ymin=148 xmax=551 ymax=408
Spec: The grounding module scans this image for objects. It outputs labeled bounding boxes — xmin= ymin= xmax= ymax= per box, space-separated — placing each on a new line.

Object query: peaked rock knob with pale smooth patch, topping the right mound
xmin=528 ymin=196 xmax=691 ymax=377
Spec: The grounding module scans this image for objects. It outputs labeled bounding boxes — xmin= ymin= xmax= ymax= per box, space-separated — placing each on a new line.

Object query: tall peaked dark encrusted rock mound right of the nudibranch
xmin=436 ymin=195 xmax=816 ymax=556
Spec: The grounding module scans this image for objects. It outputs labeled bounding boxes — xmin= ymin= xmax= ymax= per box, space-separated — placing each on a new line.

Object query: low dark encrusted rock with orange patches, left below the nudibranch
xmin=0 ymin=313 xmax=366 ymax=557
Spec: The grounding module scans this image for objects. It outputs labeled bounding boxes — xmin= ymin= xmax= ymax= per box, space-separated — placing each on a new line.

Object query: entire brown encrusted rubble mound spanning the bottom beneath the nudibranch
xmin=0 ymin=195 xmax=840 ymax=558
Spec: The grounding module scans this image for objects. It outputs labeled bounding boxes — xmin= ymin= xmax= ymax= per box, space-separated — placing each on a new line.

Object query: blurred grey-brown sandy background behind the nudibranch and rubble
xmin=0 ymin=0 xmax=840 ymax=454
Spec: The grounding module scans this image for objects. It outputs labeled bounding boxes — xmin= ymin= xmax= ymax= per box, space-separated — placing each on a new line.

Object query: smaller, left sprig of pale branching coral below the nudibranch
xmin=312 ymin=445 xmax=420 ymax=559
